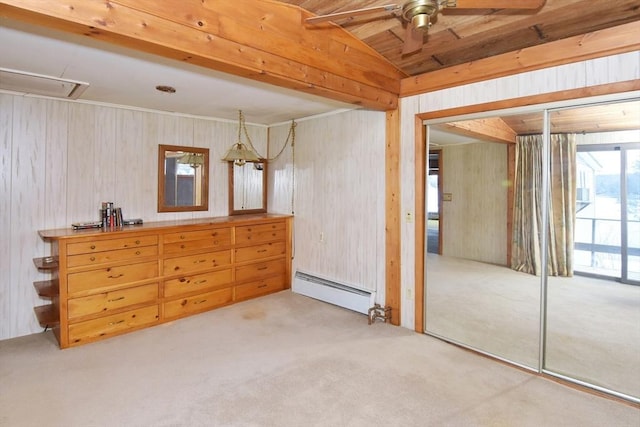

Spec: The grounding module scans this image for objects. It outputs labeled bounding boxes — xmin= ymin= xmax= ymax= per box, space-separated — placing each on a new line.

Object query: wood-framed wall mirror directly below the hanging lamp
xmin=229 ymin=162 xmax=267 ymax=215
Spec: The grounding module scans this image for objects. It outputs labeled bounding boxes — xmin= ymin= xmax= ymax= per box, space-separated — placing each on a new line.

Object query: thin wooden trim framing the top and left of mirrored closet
xmin=414 ymin=79 xmax=640 ymax=332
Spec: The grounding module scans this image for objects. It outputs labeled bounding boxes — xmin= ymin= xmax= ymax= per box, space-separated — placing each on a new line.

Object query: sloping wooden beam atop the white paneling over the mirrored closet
xmin=400 ymin=21 xmax=640 ymax=97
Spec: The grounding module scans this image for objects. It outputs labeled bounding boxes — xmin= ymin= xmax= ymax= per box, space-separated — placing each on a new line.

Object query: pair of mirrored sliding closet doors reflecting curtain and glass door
xmin=425 ymin=100 xmax=640 ymax=402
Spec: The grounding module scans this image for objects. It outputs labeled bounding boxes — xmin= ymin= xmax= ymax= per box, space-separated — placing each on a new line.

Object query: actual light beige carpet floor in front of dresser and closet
xmin=0 ymin=291 xmax=640 ymax=427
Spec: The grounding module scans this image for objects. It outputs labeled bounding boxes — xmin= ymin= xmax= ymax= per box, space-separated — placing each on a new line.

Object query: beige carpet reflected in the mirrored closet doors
xmin=426 ymin=254 xmax=640 ymax=396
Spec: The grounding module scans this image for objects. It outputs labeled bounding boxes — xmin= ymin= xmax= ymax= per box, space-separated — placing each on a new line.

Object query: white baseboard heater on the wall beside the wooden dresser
xmin=291 ymin=271 xmax=376 ymax=314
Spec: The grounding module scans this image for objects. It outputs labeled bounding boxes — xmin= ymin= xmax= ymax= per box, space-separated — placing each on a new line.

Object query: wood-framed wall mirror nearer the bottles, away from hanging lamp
xmin=158 ymin=145 xmax=209 ymax=212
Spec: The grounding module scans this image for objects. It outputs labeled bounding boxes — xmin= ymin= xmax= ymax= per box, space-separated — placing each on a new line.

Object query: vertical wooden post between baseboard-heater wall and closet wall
xmin=385 ymin=109 xmax=402 ymax=326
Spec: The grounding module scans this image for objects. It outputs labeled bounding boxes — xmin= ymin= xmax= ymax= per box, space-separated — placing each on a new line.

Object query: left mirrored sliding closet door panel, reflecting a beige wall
xmin=425 ymin=112 xmax=543 ymax=369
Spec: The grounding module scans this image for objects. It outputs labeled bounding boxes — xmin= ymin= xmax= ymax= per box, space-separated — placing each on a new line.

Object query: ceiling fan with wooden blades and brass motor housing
xmin=305 ymin=0 xmax=545 ymax=55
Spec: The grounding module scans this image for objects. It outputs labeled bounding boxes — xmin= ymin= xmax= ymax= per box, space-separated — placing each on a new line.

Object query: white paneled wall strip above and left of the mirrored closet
xmin=401 ymin=51 xmax=640 ymax=329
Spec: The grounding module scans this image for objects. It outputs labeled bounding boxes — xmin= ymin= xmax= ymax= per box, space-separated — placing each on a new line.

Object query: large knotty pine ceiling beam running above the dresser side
xmin=0 ymin=0 xmax=406 ymax=111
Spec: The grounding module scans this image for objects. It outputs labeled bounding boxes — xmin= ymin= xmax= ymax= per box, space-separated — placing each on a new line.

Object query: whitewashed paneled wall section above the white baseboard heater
xmin=269 ymin=110 xmax=385 ymax=304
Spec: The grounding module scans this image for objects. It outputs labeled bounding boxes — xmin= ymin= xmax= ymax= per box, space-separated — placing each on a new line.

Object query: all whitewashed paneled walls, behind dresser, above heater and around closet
xmin=0 ymin=52 xmax=640 ymax=339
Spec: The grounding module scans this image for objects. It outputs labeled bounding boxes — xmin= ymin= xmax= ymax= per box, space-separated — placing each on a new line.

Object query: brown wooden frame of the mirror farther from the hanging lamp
xmin=158 ymin=144 xmax=209 ymax=212
